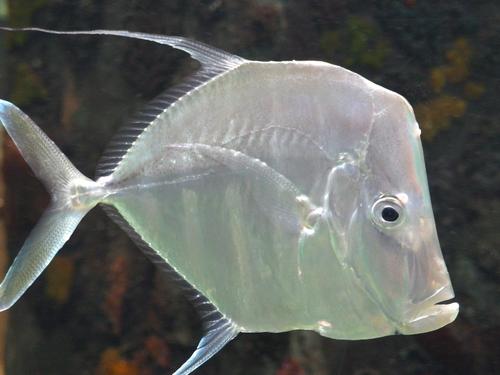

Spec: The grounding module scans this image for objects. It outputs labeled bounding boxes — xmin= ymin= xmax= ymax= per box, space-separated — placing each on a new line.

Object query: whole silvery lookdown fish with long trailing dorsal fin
xmin=0 ymin=28 xmax=459 ymax=375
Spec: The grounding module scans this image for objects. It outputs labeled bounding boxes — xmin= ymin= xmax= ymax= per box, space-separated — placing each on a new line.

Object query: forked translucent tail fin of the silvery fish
xmin=0 ymin=100 xmax=99 ymax=311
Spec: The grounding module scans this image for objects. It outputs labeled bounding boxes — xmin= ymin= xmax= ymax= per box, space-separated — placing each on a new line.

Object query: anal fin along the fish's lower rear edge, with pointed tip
xmin=101 ymin=204 xmax=239 ymax=375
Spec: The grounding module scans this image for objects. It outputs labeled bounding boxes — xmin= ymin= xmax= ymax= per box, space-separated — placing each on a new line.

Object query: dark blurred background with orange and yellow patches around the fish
xmin=0 ymin=0 xmax=500 ymax=375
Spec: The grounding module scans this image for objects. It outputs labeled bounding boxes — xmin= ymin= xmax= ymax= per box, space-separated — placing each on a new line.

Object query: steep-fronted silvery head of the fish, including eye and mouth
xmin=334 ymin=88 xmax=458 ymax=335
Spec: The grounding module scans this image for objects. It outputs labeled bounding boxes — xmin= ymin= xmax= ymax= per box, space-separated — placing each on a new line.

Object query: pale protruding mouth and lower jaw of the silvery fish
xmin=397 ymin=285 xmax=459 ymax=335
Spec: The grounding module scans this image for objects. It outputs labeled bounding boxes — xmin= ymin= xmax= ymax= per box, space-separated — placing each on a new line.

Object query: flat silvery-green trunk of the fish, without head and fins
xmin=105 ymin=62 xmax=390 ymax=338
